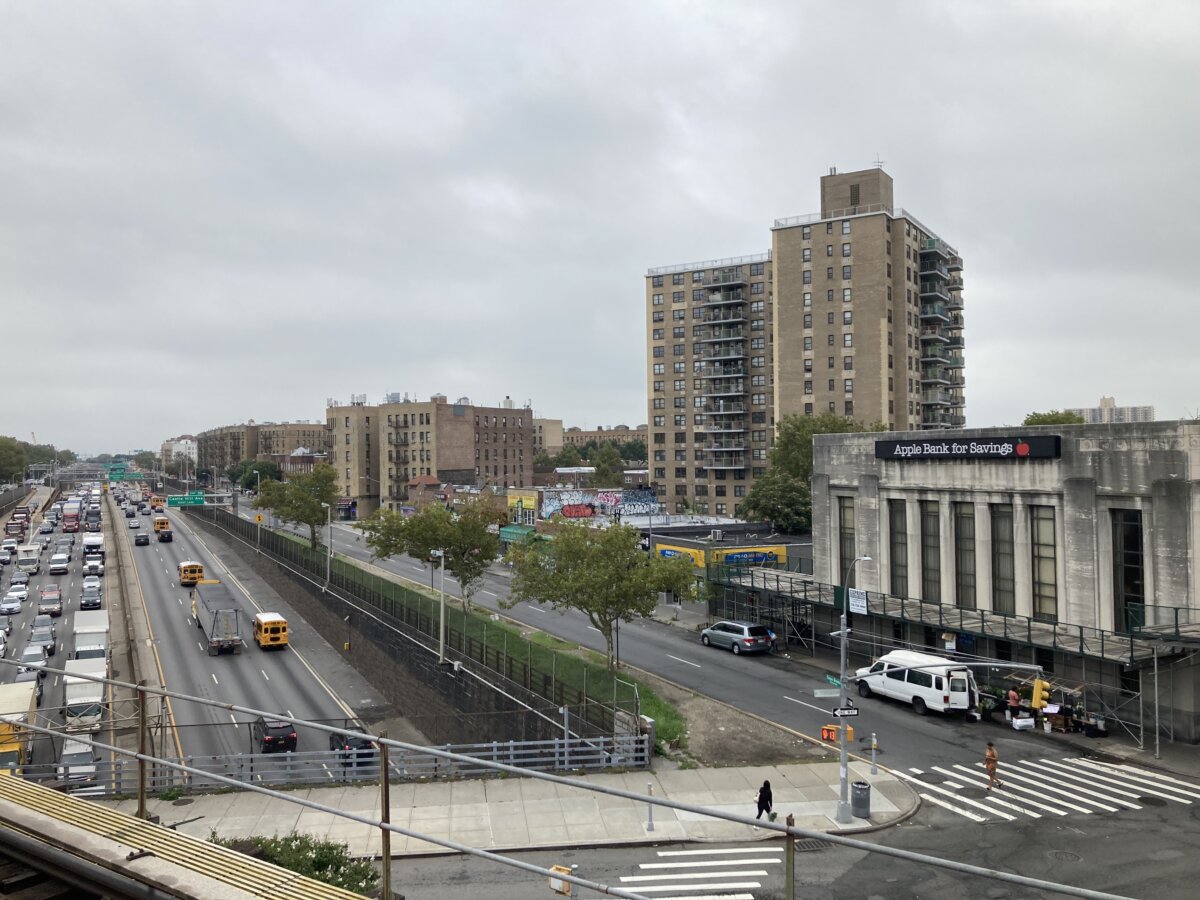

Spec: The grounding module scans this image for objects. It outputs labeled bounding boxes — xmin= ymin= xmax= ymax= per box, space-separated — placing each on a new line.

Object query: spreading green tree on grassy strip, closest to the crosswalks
xmin=500 ymin=524 xmax=694 ymax=672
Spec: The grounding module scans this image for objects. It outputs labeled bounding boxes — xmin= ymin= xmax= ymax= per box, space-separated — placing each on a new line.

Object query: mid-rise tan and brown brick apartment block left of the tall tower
xmin=326 ymin=394 xmax=534 ymax=518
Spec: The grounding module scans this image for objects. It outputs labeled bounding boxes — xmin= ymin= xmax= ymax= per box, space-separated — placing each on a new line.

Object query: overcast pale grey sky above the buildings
xmin=0 ymin=0 xmax=1200 ymax=452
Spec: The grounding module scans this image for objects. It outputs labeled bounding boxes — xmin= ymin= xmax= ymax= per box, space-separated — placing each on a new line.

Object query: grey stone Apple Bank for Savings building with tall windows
xmin=710 ymin=422 xmax=1200 ymax=744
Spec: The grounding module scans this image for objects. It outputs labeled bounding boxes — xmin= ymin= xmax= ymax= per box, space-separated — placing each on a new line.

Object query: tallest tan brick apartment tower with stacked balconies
xmin=646 ymin=168 xmax=965 ymax=515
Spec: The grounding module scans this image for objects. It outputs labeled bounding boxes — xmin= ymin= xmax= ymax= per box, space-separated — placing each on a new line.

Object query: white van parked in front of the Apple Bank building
xmin=854 ymin=650 xmax=979 ymax=715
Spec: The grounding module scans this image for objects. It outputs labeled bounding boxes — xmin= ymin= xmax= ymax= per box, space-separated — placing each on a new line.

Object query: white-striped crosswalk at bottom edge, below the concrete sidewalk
xmin=620 ymin=846 xmax=784 ymax=900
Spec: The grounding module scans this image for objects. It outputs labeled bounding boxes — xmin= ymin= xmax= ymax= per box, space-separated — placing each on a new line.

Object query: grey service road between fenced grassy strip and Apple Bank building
xmin=250 ymin=505 xmax=1012 ymax=767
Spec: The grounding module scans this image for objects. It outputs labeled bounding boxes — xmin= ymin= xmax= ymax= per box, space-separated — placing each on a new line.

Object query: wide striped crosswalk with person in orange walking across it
xmin=895 ymin=756 xmax=1200 ymax=822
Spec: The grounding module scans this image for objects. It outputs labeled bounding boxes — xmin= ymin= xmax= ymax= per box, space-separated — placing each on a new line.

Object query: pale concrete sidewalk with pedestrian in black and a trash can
xmin=104 ymin=762 xmax=919 ymax=857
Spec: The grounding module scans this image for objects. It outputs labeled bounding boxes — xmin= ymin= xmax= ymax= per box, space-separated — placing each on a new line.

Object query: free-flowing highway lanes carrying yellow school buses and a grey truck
xmin=114 ymin=494 xmax=354 ymax=756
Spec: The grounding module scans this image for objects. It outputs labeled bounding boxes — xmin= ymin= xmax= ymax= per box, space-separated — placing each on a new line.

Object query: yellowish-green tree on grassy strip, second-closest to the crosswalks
xmin=359 ymin=500 xmax=506 ymax=610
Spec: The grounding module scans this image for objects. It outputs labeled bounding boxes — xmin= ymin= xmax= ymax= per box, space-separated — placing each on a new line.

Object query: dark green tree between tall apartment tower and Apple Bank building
xmin=742 ymin=412 xmax=883 ymax=532
